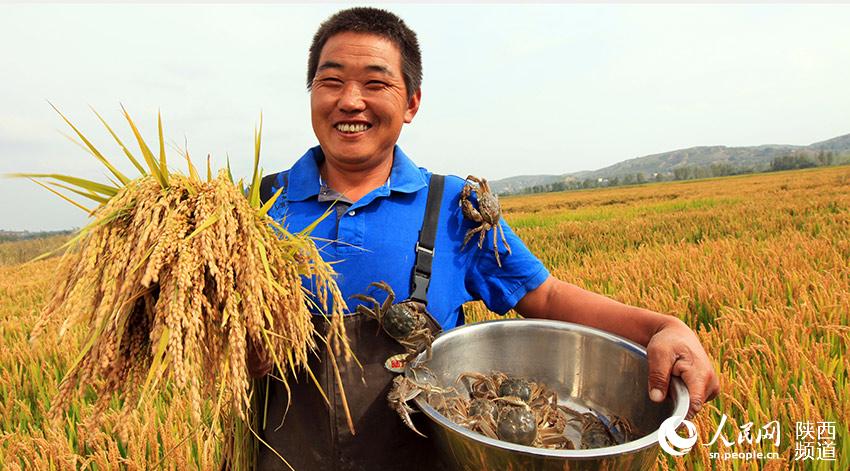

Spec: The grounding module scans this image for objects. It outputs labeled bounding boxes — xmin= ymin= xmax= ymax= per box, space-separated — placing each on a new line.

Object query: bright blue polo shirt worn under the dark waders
xmin=269 ymin=146 xmax=549 ymax=329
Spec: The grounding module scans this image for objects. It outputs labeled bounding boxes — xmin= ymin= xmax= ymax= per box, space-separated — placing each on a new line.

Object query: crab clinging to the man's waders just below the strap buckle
xmin=352 ymin=281 xmax=434 ymax=363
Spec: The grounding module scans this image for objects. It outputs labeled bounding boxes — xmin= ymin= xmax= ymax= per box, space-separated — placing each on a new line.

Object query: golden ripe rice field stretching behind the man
xmin=0 ymin=167 xmax=850 ymax=470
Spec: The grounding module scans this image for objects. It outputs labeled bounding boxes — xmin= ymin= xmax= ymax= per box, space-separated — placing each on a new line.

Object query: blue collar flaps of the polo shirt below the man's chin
xmin=286 ymin=145 xmax=428 ymax=201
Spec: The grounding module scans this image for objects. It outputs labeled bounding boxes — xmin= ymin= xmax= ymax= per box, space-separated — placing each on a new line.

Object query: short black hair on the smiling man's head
xmin=307 ymin=7 xmax=422 ymax=100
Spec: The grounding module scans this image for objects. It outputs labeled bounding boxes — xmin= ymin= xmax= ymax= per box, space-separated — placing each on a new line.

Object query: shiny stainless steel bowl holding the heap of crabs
xmin=405 ymin=319 xmax=689 ymax=470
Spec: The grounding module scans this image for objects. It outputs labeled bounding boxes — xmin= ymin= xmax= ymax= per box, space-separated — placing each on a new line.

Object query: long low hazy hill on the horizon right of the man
xmin=490 ymin=134 xmax=850 ymax=193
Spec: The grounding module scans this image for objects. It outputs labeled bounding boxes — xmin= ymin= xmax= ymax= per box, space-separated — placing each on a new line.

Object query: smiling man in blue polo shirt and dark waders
xmin=258 ymin=8 xmax=719 ymax=469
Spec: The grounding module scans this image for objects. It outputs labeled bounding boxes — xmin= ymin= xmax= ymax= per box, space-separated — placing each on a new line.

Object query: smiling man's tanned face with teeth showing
xmin=310 ymin=32 xmax=420 ymax=169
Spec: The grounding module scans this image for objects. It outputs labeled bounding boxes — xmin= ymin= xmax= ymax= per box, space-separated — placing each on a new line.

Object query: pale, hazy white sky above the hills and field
xmin=0 ymin=3 xmax=850 ymax=231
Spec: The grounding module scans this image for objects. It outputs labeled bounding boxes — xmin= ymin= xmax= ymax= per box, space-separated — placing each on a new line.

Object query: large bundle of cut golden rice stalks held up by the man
xmin=16 ymin=105 xmax=353 ymax=465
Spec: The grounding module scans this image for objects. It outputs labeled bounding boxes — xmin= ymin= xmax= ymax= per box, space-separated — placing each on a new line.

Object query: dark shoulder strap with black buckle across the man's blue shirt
xmin=410 ymin=174 xmax=445 ymax=305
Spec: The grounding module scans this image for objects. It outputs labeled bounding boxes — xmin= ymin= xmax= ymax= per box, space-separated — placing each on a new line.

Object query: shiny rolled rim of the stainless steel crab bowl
xmin=404 ymin=319 xmax=690 ymax=459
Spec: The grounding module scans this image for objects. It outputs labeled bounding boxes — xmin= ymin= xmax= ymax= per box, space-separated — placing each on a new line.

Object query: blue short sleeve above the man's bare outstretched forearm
xmin=466 ymin=221 xmax=549 ymax=314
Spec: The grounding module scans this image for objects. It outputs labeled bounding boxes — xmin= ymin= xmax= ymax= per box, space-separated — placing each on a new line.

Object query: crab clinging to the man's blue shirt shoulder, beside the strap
xmin=458 ymin=175 xmax=511 ymax=267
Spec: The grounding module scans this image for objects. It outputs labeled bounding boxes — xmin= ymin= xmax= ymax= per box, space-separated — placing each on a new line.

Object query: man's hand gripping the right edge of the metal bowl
xmin=646 ymin=317 xmax=720 ymax=419
